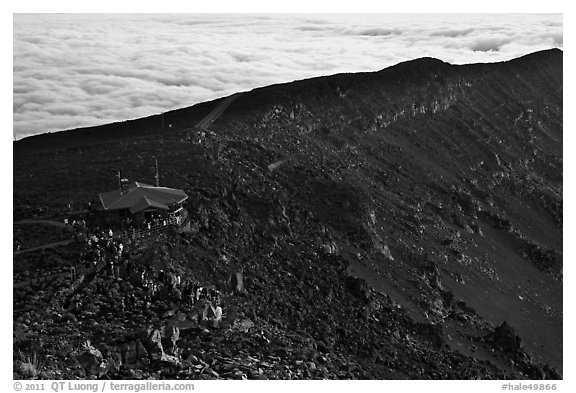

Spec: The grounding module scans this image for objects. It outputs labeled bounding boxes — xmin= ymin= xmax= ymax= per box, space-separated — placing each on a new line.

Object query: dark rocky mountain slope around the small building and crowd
xmin=14 ymin=50 xmax=563 ymax=379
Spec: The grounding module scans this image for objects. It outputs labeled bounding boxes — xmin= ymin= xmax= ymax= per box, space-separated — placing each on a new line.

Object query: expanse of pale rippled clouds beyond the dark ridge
xmin=13 ymin=14 xmax=563 ymax=138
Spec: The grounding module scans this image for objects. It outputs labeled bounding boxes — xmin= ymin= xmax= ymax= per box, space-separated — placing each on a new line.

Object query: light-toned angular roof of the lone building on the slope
xmin=98 ymin=182 xmax=188 ymax=214
